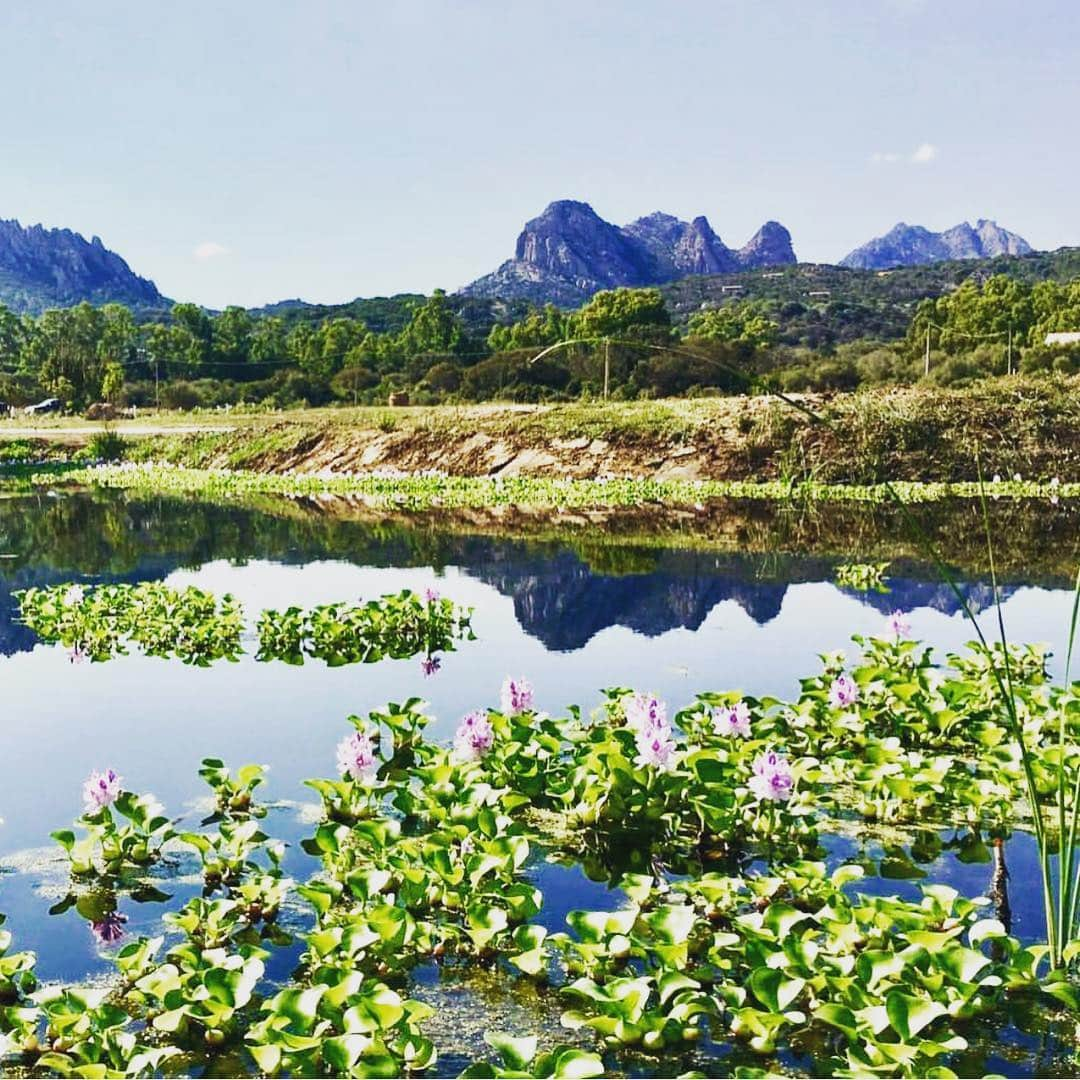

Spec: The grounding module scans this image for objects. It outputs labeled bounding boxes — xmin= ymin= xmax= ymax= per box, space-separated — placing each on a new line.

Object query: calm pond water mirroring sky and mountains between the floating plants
xmin=0 ymin=492 xmax=1075 ymax=1075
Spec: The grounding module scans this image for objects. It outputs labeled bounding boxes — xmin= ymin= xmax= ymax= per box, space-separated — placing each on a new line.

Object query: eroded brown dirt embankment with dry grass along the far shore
xmin=138 ymin=379 xmax=1080 ymax=483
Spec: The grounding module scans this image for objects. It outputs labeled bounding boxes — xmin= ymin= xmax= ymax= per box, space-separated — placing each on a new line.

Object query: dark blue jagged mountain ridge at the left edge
xmin=0 ymin=220 xmax=168 ymax=314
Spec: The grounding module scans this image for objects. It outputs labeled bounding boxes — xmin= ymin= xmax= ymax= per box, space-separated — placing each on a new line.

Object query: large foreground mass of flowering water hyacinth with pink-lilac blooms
xmin=6 ymin=630 xmax=1080 ymax=1077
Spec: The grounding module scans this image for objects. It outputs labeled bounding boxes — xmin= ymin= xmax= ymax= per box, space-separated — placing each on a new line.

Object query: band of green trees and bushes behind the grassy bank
xmin=0 ymin=274 xmax=1080 ymax=408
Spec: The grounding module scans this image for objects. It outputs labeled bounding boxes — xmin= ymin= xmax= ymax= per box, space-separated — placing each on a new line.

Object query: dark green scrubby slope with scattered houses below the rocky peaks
xmin=661 ymin=247 xmax=1080 ymax=348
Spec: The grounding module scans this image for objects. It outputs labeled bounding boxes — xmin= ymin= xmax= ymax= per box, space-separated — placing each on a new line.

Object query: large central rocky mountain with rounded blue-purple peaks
xmin=460 ymin=199 xmax=795 ymax=308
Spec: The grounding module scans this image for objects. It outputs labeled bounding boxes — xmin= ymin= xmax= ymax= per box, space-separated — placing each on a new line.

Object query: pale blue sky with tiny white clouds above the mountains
xmin=0 ymin=0 xmax=1080 ymax=308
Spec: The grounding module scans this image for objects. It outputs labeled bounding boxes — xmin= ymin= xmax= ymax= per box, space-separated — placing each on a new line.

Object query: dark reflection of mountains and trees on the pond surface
xmin=0 ymin=492 xmax=1065 ymax=656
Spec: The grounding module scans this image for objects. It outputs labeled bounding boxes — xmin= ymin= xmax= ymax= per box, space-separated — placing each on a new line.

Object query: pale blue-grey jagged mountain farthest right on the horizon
xmin=840 ymin=218 xmax=1031 ymax=270
